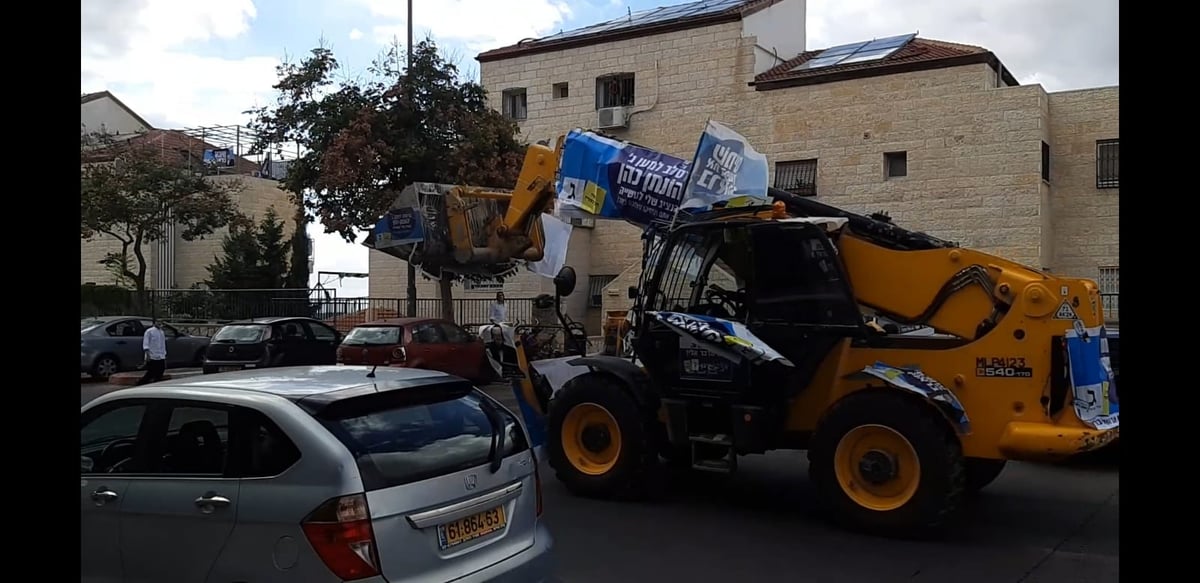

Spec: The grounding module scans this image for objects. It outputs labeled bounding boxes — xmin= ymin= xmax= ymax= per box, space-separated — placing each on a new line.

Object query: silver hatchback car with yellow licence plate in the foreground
xmin=79 ymin=366 xmax=552 ymax=583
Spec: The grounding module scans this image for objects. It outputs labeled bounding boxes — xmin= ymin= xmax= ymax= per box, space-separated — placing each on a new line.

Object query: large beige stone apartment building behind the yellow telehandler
xmin=371 ymin=0 xmax=1120 ymax=333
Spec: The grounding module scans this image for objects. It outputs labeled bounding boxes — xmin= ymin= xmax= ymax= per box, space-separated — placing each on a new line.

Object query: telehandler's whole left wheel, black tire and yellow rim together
xmin=546 ymin=373 xmax=658 ymax=499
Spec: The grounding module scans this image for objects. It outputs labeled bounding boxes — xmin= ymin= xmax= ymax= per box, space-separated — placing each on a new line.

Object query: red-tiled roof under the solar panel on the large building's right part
xmin=754 ymin=38 xmax=998 ymax=89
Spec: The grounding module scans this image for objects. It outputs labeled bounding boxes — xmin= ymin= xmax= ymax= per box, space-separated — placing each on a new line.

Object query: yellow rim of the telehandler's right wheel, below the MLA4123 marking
xmin=834 ymin=425 xmax=920 ymax=512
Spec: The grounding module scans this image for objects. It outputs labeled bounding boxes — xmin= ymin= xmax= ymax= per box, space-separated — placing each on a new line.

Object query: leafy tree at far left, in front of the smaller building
xmin=79 ymin=136 xmax=241 ymax=292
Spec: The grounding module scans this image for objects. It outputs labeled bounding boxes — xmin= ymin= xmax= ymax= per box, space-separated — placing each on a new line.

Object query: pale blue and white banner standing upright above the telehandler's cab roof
xmin=679 ymin=121 xmax=770 ymax=211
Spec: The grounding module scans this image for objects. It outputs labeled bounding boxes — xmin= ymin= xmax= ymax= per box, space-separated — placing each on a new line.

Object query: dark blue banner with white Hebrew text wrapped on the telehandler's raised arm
xmin=557 ymin=130 xmax=690 ymax=226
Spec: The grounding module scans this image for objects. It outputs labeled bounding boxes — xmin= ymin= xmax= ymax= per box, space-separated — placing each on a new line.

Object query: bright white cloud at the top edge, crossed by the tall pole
xmin=356 ymin=0 xmax=571 ymax=51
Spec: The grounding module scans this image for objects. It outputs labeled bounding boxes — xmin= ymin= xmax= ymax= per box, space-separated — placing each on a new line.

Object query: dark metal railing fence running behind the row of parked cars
xmin=79 ymin=286 xmax=534 ymax=331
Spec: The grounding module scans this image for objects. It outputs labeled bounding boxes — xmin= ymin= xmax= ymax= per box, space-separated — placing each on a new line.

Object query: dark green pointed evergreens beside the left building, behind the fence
xmin=205 ymin=209 xmax=292 ymax=289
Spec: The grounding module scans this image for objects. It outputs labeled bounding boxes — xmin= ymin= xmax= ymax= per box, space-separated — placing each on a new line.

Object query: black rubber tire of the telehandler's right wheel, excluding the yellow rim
xmin=809 ymin=390 xmax=966 ymax=539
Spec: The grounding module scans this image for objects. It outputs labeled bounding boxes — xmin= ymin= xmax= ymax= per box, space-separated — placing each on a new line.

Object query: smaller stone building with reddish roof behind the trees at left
xmin=79 ymin=91 xmax=304 ymax=289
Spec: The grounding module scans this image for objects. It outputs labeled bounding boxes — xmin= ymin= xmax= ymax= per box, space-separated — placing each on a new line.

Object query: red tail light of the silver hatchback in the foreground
xmin=301 ymin=494 xmax=379 ymax=581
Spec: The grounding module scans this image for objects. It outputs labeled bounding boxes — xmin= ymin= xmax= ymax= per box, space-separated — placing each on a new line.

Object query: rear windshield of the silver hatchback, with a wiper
xmin=317 ymin=385 xmax=529 ymax=491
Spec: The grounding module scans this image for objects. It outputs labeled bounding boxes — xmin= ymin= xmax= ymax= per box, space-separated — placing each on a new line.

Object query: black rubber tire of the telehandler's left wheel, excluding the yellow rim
xmin=546 ymin=373 xmax=658 ymax=499
